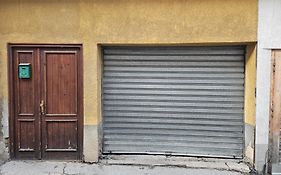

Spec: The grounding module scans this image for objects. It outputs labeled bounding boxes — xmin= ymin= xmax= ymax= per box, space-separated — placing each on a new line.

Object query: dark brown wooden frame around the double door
xmin=7 ymin=43 xmax=84 ymax=160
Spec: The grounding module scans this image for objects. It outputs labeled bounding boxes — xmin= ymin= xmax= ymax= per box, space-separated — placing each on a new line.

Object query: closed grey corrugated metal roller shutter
xmin=103 ymin=46 xmax=245 ymax=157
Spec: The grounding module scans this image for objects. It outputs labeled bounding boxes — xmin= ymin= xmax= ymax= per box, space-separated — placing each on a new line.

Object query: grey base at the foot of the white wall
xmin=255 ymin=144 xmax=268 ymax=172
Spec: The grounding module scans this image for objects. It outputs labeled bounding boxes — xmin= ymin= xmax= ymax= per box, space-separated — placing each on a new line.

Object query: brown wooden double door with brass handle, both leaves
xmin=9 ymin=45 xmax=83 ymax=160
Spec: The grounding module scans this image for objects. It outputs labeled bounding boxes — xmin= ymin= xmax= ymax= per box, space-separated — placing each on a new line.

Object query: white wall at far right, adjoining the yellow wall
xmin=255 ymin=0 xmax=281 ymax=171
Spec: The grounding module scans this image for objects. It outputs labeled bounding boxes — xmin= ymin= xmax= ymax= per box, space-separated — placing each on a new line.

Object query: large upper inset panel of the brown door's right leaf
xmin=45 ymin=51 xmax=77 ymax=115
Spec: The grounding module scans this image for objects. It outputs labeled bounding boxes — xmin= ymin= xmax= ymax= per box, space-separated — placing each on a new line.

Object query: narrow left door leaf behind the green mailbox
xmin=13 ymin=48 xmax=40 ymax=159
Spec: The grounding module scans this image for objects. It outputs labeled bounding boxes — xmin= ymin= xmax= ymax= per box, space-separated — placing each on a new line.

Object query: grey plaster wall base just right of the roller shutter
xmin=245 ymin=123 xmax=255 ymax=165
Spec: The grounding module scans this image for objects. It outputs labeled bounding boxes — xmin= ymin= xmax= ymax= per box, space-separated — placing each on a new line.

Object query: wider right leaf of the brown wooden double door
xmin=41 ymin=49 xmax=79 ymax=159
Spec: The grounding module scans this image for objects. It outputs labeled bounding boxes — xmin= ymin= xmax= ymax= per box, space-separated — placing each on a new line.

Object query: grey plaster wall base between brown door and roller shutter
xmin=83 ymin=125 xmax=99 ymax=163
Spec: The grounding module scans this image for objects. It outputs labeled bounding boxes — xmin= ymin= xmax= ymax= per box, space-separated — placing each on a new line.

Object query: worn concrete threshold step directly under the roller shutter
xmin=100 ymin=155 xmax=251 ymax=174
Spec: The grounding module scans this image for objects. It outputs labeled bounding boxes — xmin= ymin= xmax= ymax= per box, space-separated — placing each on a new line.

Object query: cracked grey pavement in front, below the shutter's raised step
xmin=0 ymin=161 xmax=248 ymax=175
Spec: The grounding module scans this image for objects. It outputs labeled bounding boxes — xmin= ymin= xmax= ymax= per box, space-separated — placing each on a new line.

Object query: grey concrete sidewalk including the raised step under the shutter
xmin=0 ymin=156 xmax=250 ymax=175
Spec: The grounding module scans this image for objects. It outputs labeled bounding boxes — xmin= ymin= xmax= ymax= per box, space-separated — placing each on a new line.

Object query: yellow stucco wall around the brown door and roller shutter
xmin=0 ymin=0 xmax=257 ymax=125
